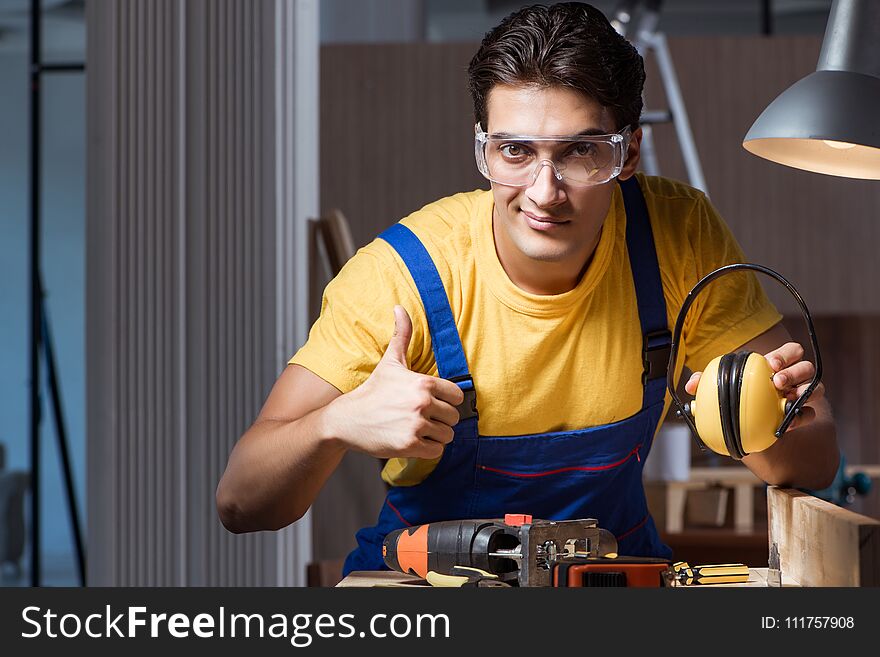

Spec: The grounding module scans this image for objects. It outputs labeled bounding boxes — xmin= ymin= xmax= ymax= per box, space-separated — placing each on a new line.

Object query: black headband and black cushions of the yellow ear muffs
xmin=666 ymin=262 xmax=822 ymax=458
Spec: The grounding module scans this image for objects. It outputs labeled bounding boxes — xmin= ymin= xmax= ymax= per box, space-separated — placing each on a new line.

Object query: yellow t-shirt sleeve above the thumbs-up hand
xmin=289 ymin=240 xmax=430 ymax=393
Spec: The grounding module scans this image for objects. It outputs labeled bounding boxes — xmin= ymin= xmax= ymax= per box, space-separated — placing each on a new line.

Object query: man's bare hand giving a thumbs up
xmin=328 ymin=306 xmax=464 ymax=459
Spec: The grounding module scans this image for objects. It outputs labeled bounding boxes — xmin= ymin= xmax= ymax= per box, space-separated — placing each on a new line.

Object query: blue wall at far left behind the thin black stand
xmin=0 ymin=24 xmax=86 ymax=585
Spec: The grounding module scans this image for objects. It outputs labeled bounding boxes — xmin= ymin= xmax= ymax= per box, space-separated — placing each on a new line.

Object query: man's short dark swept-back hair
xmin=468 ymin=2 xmax=645 ymax=130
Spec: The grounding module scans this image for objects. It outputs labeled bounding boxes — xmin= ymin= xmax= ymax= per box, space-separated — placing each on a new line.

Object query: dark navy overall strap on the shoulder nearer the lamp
xmin=618 ymin=176 xmax=672 ymax=408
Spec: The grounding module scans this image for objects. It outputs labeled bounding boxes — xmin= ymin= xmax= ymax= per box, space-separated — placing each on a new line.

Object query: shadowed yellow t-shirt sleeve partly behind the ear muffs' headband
xmin=664 ymin=194 xmax=782 ymax=371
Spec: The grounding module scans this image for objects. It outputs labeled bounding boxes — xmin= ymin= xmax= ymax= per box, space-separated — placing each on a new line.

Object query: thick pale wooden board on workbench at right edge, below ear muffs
xmin=767 ymin=486 xmax=880 ymax=586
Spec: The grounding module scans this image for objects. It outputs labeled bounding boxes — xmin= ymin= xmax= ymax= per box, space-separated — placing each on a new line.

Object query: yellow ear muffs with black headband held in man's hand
xmin=666 ymin=263 xmax=822 ymax=460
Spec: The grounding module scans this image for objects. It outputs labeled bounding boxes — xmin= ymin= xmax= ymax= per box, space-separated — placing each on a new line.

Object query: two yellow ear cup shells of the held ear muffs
xmin=690 ymin=353 xmax=786 ymax=456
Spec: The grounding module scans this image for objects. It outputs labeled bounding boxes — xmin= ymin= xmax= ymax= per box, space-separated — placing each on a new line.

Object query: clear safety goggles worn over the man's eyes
xmin=476 ymin=133 xmax=625 ymax=187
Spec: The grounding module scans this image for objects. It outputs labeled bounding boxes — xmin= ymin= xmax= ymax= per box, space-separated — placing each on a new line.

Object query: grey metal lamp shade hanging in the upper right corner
xmin=743 ymin=0 xmax=880 ymax=180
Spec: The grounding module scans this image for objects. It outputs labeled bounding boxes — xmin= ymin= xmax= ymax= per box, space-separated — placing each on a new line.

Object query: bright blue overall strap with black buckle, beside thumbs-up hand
xmin=379 ymin=223 xmax=477 ymax=428
